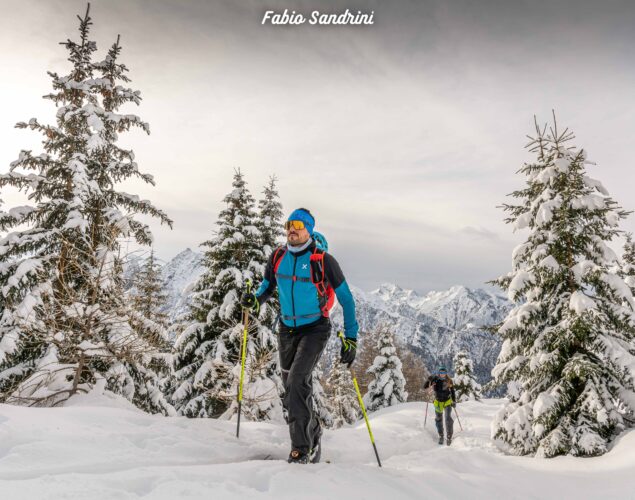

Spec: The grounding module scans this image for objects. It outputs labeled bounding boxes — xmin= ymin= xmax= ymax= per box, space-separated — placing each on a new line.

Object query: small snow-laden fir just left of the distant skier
xmin=364 ymin=325 xmax=408 ymax=411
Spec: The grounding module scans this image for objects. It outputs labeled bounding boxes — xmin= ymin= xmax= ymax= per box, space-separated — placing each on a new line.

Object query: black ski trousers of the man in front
xmin=278 ymin=320 xmax=331 ymax=453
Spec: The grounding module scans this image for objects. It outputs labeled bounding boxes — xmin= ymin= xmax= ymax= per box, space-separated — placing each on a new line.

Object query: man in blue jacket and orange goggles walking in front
xmin=241 ymin=208 xmax=359 ymax=463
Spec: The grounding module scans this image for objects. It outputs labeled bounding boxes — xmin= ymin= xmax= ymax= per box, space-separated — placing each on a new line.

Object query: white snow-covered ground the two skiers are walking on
xmin=0 ymin=395 xmax=635 ymax=500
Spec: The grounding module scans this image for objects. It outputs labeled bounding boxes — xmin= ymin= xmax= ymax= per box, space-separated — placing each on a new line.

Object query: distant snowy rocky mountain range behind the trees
xmin=126 ymin=248 xmax=512 ymax=382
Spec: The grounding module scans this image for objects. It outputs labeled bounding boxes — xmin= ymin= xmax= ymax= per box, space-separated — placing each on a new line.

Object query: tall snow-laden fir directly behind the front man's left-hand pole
xmin=172 ymin=171 xmax=282 ymax=420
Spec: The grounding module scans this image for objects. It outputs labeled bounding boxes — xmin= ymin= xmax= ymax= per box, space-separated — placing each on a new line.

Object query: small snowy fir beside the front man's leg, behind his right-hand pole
xmin=324 ymin=362 xmax=362 ymax=429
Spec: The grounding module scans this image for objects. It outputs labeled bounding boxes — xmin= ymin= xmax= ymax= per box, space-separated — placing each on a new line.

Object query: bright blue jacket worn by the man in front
xmin=256 ymin=242 xmax=359 ymax=339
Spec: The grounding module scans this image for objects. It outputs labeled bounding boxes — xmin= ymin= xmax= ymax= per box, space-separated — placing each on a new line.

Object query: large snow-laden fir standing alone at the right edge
xmin=492 ymin=118 xmax=635 ymax=457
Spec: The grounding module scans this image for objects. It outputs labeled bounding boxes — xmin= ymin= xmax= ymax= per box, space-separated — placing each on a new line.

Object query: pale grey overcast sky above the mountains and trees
xmin=0 ymin=0 xmax=635 ymax=292
